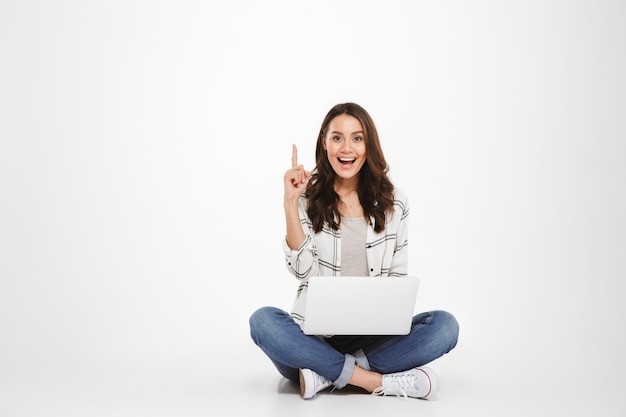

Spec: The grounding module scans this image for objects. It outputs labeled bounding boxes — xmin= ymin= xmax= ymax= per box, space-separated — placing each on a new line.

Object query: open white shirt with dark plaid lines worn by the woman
xmin=283 ymin=189 xmax=409 ymax=324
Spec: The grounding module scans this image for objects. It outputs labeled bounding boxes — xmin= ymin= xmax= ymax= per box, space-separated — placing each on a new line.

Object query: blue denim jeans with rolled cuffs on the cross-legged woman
xmin=250 ymin=307 xmax=459 ymax=388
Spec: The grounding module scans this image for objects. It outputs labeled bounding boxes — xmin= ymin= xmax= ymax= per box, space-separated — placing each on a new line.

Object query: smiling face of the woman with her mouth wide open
xmin=324 ymin=114 xmax=366 ymax=179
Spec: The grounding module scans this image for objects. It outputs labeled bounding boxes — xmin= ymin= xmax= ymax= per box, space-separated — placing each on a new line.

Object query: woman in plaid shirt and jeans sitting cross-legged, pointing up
xmin=250 ymin=103 xmax=459 ymax=399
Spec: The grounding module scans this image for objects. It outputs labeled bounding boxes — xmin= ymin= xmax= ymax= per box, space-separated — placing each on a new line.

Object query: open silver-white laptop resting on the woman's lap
xmin=302 ymin=276 xmax=419 ymax=336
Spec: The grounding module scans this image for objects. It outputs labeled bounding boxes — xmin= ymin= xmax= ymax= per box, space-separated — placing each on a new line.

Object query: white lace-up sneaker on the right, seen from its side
xmin=372 ymin=366 xmax=439 ymax=400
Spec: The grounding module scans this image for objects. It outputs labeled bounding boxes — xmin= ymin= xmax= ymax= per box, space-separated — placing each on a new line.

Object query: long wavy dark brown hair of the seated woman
xmin=305 ymin=103 xmax=394 ymax=233
